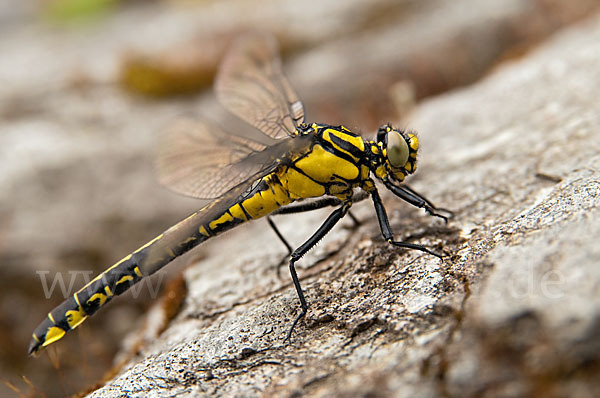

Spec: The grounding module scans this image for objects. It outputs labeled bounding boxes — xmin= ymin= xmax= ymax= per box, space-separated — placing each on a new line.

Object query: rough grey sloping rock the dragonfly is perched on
xmin=91 ymin=10 xmax=600 ymax=397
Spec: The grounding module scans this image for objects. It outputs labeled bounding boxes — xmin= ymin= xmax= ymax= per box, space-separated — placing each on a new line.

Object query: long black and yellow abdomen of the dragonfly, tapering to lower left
xmin=29 ymin=174 xmax=292 ymax=354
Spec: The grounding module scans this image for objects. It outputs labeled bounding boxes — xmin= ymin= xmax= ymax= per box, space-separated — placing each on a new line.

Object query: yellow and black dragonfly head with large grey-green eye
xmin=375 ymin=124 xmax=419 ymax=181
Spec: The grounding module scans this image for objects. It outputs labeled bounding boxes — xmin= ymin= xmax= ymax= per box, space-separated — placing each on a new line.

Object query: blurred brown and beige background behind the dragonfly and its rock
xmin=0 ymin=0 xmax=600 ymax=397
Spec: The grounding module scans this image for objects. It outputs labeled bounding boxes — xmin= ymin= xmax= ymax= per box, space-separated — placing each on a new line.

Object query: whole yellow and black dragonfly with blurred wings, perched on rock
xmin=29 ymin=34 xmax=448 ymax=355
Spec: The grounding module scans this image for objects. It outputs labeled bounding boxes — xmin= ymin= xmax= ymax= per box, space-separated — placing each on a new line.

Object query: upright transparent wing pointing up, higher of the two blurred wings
xmin=215 ymin=34 xmax=304 ymax=139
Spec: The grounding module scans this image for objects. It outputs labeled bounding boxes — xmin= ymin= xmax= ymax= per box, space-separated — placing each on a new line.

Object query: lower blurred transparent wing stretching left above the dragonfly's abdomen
xmin=156 ymin=119 xmax=306 ymax=199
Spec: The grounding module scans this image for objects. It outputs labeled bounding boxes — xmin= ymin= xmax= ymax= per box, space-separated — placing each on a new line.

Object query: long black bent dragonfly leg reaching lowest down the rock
xmin=284 ymin=202 xmax=352 ymax=341
